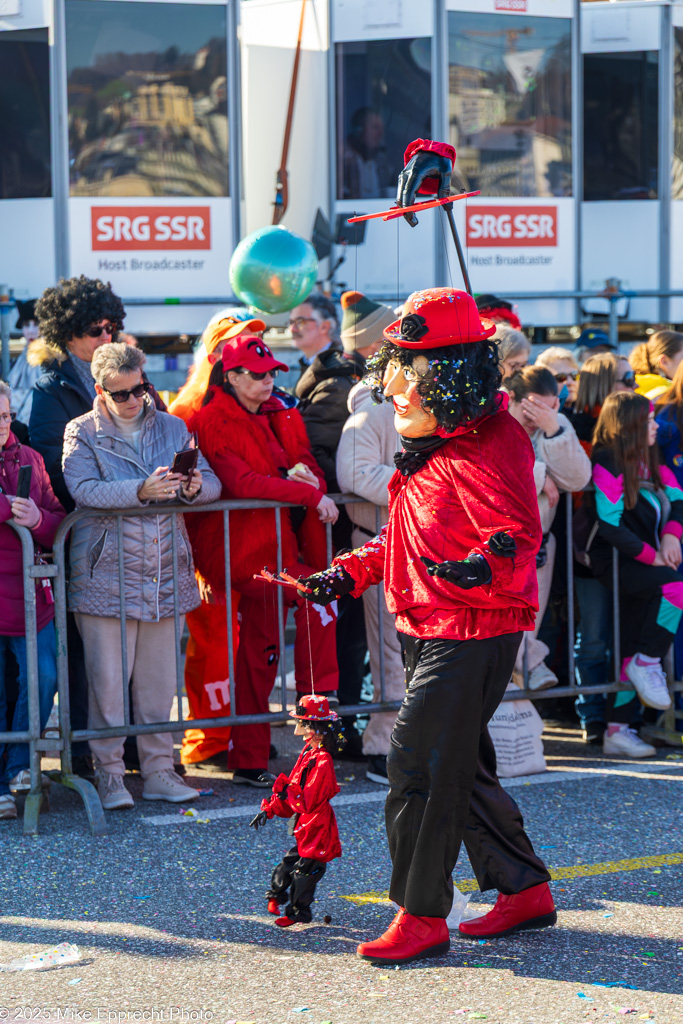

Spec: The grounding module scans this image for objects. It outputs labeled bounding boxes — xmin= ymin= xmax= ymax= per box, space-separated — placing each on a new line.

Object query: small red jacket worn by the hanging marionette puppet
xmin=261 ymin=744 xmax=341 ymax=863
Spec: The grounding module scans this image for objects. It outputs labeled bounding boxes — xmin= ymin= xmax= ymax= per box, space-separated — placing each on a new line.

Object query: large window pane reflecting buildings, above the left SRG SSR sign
xmin=67 ymin=0 xmax=228 ymax=196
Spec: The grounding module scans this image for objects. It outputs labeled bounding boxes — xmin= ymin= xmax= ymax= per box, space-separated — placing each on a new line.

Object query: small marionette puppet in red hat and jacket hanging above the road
xmin=249 ymin=694 xmax=344 ymax=928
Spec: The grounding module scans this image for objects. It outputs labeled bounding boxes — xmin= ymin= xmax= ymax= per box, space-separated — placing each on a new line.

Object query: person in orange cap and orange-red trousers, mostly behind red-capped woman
xmin=169 ymin=308 xmax=265 ymax=771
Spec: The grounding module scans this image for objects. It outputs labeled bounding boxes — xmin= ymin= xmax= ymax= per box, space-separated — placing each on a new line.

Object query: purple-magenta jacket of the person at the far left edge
xmin=0 ymin=431 xmax=67 ymax=637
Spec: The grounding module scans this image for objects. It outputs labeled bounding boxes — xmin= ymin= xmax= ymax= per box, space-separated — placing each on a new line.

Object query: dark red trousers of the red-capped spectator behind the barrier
xmin=228 ymin=564 xmax=339 ymax=771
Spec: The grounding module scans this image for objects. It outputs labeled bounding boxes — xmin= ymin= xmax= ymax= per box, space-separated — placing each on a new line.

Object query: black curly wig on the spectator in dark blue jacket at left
xmin=36 ymin=274 xmax=126 ymax=352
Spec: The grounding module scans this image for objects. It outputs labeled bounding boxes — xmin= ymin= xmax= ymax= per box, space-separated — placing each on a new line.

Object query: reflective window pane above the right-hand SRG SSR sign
xmin=449 ymin=11 xmax=571 ymax=197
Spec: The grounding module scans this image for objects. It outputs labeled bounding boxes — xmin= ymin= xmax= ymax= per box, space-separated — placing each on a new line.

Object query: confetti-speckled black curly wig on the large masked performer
xmin=366 ymin=338 xmax=503 ymax=432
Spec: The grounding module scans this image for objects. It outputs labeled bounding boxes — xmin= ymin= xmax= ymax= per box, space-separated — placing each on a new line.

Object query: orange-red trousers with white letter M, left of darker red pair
xmin=180 ymin=592 xmax=240 ymax=765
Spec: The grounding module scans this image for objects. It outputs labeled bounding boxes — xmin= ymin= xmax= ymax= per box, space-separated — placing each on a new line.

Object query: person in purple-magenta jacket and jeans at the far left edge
xmin=0 ymin=381 xmax=67 ymax=819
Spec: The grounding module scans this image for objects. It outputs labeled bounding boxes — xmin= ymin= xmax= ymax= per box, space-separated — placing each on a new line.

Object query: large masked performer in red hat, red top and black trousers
xmin=300 ymin=288 xmax=556 ymax=963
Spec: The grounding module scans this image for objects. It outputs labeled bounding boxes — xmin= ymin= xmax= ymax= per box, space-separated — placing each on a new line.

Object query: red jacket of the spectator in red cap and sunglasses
xmin=186 ymin=387 xmax=326 ymax=599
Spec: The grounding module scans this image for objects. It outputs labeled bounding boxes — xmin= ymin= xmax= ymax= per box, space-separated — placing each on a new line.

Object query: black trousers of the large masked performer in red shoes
xmin=385 ymin=633 xmax=550 ymax=918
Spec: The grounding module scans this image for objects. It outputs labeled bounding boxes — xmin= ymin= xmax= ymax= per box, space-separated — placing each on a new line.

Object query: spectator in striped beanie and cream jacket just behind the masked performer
xmin=337 ymin=292 xmax=405 ymax=785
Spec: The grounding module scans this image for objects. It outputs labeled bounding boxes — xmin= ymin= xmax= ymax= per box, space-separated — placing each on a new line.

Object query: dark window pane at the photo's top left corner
xmin=0 ymin=29 xmax=52 ymax=199
